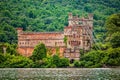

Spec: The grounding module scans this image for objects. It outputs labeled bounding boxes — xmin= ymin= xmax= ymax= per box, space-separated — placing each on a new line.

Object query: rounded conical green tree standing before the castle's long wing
xmin=30 ymin=43 xmax=47 ymax=61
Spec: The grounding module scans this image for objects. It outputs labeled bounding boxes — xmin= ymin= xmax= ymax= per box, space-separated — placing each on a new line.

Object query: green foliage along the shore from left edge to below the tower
xmin=0 ymin=43 xmax=69 ymax=68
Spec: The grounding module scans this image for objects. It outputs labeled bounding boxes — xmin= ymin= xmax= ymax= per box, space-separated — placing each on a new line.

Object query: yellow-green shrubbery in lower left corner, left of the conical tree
xmin=0 ymin=43 xmax=33 ymax=68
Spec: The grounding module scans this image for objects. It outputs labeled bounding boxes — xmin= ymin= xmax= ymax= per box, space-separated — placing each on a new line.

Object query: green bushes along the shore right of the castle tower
xmin=74 ymin=47 xmax=120 ymax=68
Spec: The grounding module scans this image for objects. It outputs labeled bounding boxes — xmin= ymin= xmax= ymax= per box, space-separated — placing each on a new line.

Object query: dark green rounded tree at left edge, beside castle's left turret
xmin=0 ymin=23 xmax=17 ymax=44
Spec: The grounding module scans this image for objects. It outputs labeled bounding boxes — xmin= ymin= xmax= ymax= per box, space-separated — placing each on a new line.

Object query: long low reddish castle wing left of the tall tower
xmin=17 ymin=28 xmax=65 ymax=57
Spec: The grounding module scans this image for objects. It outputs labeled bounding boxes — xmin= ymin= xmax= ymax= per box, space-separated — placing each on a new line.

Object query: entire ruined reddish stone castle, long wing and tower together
xmin=17 ymin=13 xmax=93 ymax=60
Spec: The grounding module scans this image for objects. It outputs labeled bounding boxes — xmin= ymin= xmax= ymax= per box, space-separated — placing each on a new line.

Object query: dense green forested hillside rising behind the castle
xmin=0 ymin=0 xmax=120 ymax=43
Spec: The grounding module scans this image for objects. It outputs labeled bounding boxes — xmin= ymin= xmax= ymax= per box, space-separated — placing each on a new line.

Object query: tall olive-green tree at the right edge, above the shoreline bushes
xmin=105 ymin=13 xmax=120 ymax=48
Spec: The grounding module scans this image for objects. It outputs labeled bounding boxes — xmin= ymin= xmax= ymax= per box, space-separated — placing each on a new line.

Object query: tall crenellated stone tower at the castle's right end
xmin=64 ymin=13 xmax=93 ymax=60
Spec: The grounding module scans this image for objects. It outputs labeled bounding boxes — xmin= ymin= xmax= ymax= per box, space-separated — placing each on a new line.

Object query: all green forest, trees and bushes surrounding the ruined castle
xmin=0 ymin=0 xmax=120 ymax=68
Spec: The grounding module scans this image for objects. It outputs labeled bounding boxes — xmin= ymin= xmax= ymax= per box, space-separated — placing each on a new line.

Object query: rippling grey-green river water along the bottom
xmin=0 ymin=68 xmax=120 ymax=80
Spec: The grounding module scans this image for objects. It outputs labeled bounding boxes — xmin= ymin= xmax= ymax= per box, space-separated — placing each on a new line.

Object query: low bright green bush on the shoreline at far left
xmin=0 ymin=54 xmax=33 ymax=68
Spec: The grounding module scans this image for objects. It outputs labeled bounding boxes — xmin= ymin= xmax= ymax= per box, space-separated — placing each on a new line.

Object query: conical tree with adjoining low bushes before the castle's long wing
xmin=30 ymin=43 xmax=69 ymax=68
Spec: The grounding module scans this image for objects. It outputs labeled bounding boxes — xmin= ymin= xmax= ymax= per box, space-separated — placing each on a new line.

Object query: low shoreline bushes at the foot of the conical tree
xmin=33 ymin=55 xmax=69 ymax=68
